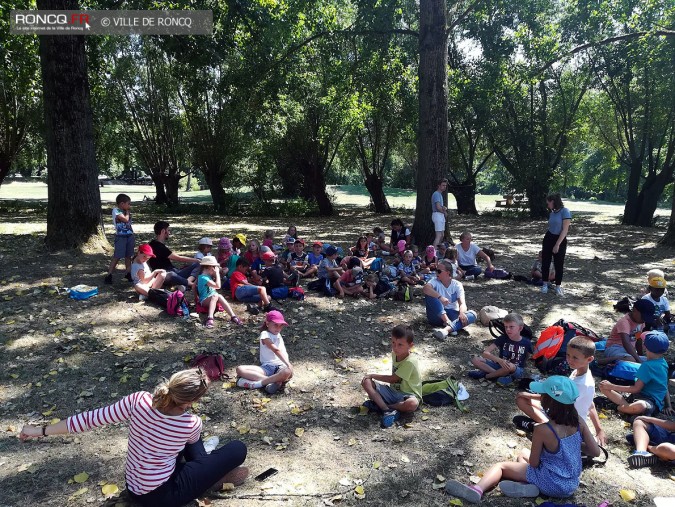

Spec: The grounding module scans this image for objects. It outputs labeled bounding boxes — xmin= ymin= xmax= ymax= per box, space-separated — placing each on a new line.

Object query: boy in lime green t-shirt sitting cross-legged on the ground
xmin=361 ymin=325 xmax=422 ymax=428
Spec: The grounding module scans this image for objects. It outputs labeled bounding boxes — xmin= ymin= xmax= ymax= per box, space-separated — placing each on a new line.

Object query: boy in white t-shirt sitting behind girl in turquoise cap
xmin=513 ymin=336 xmax=607 ymax=445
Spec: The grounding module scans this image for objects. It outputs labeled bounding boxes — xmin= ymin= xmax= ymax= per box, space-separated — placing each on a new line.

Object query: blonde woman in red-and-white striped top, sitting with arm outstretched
xmin=20 ymin=369 xmax=248 ymax=507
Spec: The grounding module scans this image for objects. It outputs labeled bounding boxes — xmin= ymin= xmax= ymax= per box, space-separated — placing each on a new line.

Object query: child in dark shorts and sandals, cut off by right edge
xmin=626 ymin=415 xmax=675 ymax=468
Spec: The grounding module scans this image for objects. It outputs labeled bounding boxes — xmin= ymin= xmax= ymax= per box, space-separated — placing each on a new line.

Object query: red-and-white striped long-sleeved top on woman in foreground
xmin=67 ymin=391 xmax=202 ymax=495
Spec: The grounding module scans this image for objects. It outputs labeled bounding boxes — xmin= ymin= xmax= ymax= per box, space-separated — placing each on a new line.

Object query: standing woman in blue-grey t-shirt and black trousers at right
xmin=541 ymin=194 xmax=572 ymax=296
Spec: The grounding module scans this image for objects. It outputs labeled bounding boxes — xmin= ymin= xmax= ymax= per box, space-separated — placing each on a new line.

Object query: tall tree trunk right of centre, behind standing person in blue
xmin=413 ymin=0 xmax=448 ymax=245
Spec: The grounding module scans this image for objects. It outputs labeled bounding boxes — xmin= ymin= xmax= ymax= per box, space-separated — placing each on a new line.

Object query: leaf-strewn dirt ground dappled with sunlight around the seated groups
xmin=0 ymin=205 xmax=675 ymax=507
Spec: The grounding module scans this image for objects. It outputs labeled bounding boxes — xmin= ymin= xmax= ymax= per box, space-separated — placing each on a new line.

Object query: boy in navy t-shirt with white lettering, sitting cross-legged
xmin=469 ymin=313 xmax=532 ymax=385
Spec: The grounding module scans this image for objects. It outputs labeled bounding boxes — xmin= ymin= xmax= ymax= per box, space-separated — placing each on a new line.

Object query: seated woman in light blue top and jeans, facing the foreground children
xmin=422 ymin=259 xmax=476 ymax=340
